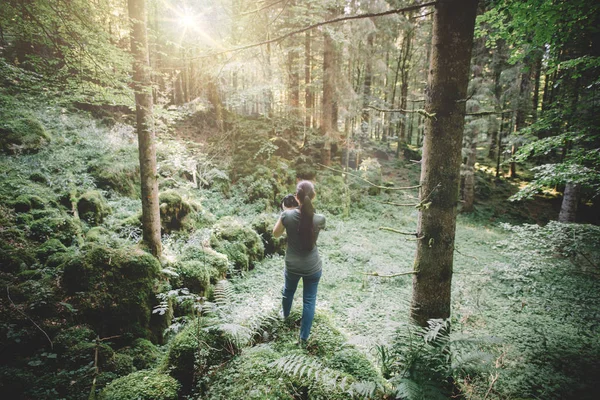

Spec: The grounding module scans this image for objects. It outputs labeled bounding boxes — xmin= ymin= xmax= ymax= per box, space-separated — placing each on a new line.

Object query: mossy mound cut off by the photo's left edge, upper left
xmin=0 ymin=116 xmax=51 ymax=154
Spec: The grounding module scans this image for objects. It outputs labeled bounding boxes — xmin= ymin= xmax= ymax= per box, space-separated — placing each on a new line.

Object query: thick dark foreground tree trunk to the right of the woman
xmin=410 ymin=0 xmax=477 ymax=326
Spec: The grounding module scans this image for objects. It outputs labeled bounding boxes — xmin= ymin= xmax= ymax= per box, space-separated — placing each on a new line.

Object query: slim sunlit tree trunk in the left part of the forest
xmin=128 ymin=0 xmax=162 ymax=257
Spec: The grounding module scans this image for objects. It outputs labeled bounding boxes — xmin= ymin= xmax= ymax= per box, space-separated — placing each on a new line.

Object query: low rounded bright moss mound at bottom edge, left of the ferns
xmin=99 ymin=370 xmax=180 ymax=400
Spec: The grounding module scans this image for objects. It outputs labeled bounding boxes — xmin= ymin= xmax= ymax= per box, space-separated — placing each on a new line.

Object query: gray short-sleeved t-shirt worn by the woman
xmin=281 ymin=209 xmax=325 ymax=276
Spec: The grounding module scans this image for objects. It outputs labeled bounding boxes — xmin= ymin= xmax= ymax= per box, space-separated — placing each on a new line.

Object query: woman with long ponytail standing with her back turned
xmin=273 ymin=181 xmax=325 ymax=344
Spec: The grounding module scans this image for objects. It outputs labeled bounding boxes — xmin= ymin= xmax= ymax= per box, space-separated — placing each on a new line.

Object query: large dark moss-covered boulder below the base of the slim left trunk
xmin=61 ymin=243 xmax=160 ymax=337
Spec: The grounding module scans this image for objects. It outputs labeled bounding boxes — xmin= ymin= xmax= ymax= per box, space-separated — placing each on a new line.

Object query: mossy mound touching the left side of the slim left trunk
xmin=88 ymin=147 xmax=140 ymax=198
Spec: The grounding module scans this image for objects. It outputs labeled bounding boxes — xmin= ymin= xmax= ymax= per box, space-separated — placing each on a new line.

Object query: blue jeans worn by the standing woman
xmin=281 ymin=271 xmax=322 ymax=340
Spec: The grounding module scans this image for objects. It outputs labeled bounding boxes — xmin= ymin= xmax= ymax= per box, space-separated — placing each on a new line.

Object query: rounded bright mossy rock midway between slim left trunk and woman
xmin=210 ymin=217 xmax=265 ymax=271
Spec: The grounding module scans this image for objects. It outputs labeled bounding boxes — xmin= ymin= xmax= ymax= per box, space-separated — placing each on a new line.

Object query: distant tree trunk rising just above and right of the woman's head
xmin=321 ymin=30 xmax=335 ymax=165
